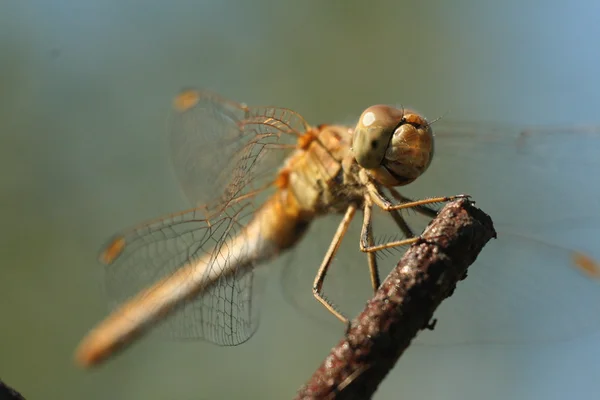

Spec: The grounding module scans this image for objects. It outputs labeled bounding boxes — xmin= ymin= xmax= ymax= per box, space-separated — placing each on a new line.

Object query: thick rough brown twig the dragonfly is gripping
xmin=296 ymin=199 xmax=496 ymax=399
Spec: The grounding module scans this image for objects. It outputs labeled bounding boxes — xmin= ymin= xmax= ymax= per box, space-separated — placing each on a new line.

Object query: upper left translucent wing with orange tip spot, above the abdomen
xmin=168 ymin=89 xmax=308 ymax=208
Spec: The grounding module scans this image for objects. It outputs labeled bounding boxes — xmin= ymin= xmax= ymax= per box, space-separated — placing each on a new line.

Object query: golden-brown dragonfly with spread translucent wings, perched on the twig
xmin=76 ymin=89 xmax=600 ymax=366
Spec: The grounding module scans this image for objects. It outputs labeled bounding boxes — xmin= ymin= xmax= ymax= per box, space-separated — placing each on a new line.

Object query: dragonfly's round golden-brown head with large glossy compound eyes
xmin=352 ymin=105 xmax=433 ymax=186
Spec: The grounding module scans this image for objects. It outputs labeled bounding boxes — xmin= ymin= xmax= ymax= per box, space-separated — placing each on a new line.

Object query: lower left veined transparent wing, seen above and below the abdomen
xmin=104 ymin=205 xmax=258 ymax=345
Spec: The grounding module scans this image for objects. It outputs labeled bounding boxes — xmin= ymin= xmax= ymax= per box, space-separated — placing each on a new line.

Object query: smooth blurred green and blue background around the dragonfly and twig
xmin=0 ymin=0 xmax=600 ymax=399
